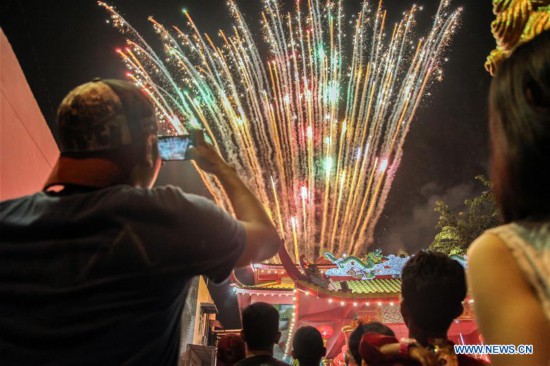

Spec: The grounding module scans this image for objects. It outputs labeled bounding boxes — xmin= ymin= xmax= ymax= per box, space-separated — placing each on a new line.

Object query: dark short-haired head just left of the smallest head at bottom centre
xmin=242 ymin=302 xmax=281 ymax=352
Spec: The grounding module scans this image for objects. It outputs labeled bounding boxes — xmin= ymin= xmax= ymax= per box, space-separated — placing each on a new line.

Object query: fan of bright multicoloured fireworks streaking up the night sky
xmin=99 ymin=0 xmax=460 ymax=261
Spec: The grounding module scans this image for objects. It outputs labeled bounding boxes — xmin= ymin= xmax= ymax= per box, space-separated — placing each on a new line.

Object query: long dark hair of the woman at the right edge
xmin=489 ymin=31 xmax=550 ymax=222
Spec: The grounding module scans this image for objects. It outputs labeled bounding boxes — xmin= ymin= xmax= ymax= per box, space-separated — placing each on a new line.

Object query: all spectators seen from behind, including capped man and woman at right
xmin=0 ymin=7 xmax=550 ymax=366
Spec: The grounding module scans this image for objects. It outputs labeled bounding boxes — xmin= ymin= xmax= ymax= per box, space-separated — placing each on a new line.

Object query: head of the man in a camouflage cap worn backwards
xmin=49 ymin=79 xmax=160 ymax=186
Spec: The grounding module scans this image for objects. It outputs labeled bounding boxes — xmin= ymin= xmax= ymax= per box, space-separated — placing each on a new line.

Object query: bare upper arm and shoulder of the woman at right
xmin=468 ymin=234 xmax=550 ymax=366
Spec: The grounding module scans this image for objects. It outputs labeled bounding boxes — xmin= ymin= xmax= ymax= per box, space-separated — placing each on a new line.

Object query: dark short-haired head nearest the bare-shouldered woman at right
xmin=401 ymin=251 xmax=466 ymax=335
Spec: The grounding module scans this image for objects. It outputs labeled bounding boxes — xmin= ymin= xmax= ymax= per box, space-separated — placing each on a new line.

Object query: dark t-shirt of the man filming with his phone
xmin=0 ymin=186 xmax=245 ymax=365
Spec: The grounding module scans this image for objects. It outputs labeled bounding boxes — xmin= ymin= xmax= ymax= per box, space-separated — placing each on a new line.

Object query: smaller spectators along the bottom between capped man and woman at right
xmin=222 ymin=251 xmax=486 ymax=366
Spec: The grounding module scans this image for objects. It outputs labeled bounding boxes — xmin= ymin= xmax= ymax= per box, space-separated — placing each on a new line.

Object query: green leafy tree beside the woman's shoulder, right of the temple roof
xmin=430 ymin=175 xmax=500 ymax=255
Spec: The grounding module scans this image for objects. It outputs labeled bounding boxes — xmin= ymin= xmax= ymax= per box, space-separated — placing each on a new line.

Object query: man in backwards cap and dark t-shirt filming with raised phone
xmin=0 ymin=79 xmax=281 ymax=365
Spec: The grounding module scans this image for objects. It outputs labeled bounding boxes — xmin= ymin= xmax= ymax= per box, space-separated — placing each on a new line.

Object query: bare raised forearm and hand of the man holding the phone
xmin=189 ymin=130 xmax=281 ymax=267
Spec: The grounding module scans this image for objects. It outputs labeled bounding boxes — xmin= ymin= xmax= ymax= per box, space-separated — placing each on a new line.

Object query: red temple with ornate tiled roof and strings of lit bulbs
xmin=234 ymin=247 xmax=488 ymax=365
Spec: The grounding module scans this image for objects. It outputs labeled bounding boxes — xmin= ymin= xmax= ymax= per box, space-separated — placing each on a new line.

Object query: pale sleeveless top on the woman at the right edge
xmin=487 ymin=221 xmax=550 ymax=323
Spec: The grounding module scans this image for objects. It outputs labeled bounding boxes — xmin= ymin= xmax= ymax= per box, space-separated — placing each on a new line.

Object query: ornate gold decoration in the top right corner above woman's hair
xmin=485 ymin=0 xmax=550 ymax=75
